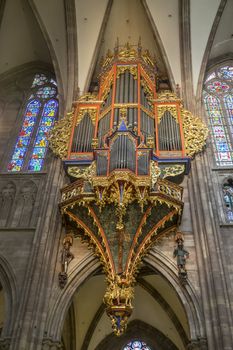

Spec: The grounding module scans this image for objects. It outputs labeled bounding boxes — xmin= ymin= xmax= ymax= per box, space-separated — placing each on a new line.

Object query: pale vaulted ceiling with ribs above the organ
xmin=0 ymin=0 xmax=230 ymax=106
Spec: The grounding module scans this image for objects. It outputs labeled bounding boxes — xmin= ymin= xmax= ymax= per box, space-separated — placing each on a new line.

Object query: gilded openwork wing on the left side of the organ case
xmin=48 ymin=111 xmax=74 ymax=158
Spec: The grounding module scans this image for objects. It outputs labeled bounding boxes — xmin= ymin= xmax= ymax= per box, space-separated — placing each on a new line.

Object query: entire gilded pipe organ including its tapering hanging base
xmin=50 ymin=44 xmax=207 ymax=335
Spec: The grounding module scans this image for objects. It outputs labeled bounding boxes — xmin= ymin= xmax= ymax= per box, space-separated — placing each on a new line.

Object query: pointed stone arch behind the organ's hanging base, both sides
xmin=45 ymin=249 xmax=205 ymax=341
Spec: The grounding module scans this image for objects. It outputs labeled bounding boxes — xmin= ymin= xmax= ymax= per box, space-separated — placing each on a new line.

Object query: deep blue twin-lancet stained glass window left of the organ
xmin=8 ymin=74 xmax=58 ymax=172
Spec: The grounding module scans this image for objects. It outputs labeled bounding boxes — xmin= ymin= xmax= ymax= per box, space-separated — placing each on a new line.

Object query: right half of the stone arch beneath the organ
xmin=144 ymin=249 xmax=205 ymax=340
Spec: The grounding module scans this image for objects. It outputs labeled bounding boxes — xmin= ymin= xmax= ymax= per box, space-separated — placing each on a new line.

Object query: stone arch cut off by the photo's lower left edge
xmin=0 ymin=255 xmax=18 ymax=338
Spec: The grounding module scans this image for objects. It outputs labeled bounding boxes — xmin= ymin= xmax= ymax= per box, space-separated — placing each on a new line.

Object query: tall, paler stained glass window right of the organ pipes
xmin=203 ymin=65 xmax=233 ymax=166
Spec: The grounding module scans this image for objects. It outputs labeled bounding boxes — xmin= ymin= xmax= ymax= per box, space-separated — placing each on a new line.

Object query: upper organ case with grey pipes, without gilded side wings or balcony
xmin=65 ymin=45 xmax=198 ymax=176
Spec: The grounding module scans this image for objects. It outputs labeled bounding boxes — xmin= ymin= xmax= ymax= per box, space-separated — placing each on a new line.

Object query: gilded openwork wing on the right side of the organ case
xmin=181 ymin=109 xmax=209 ymax=157
